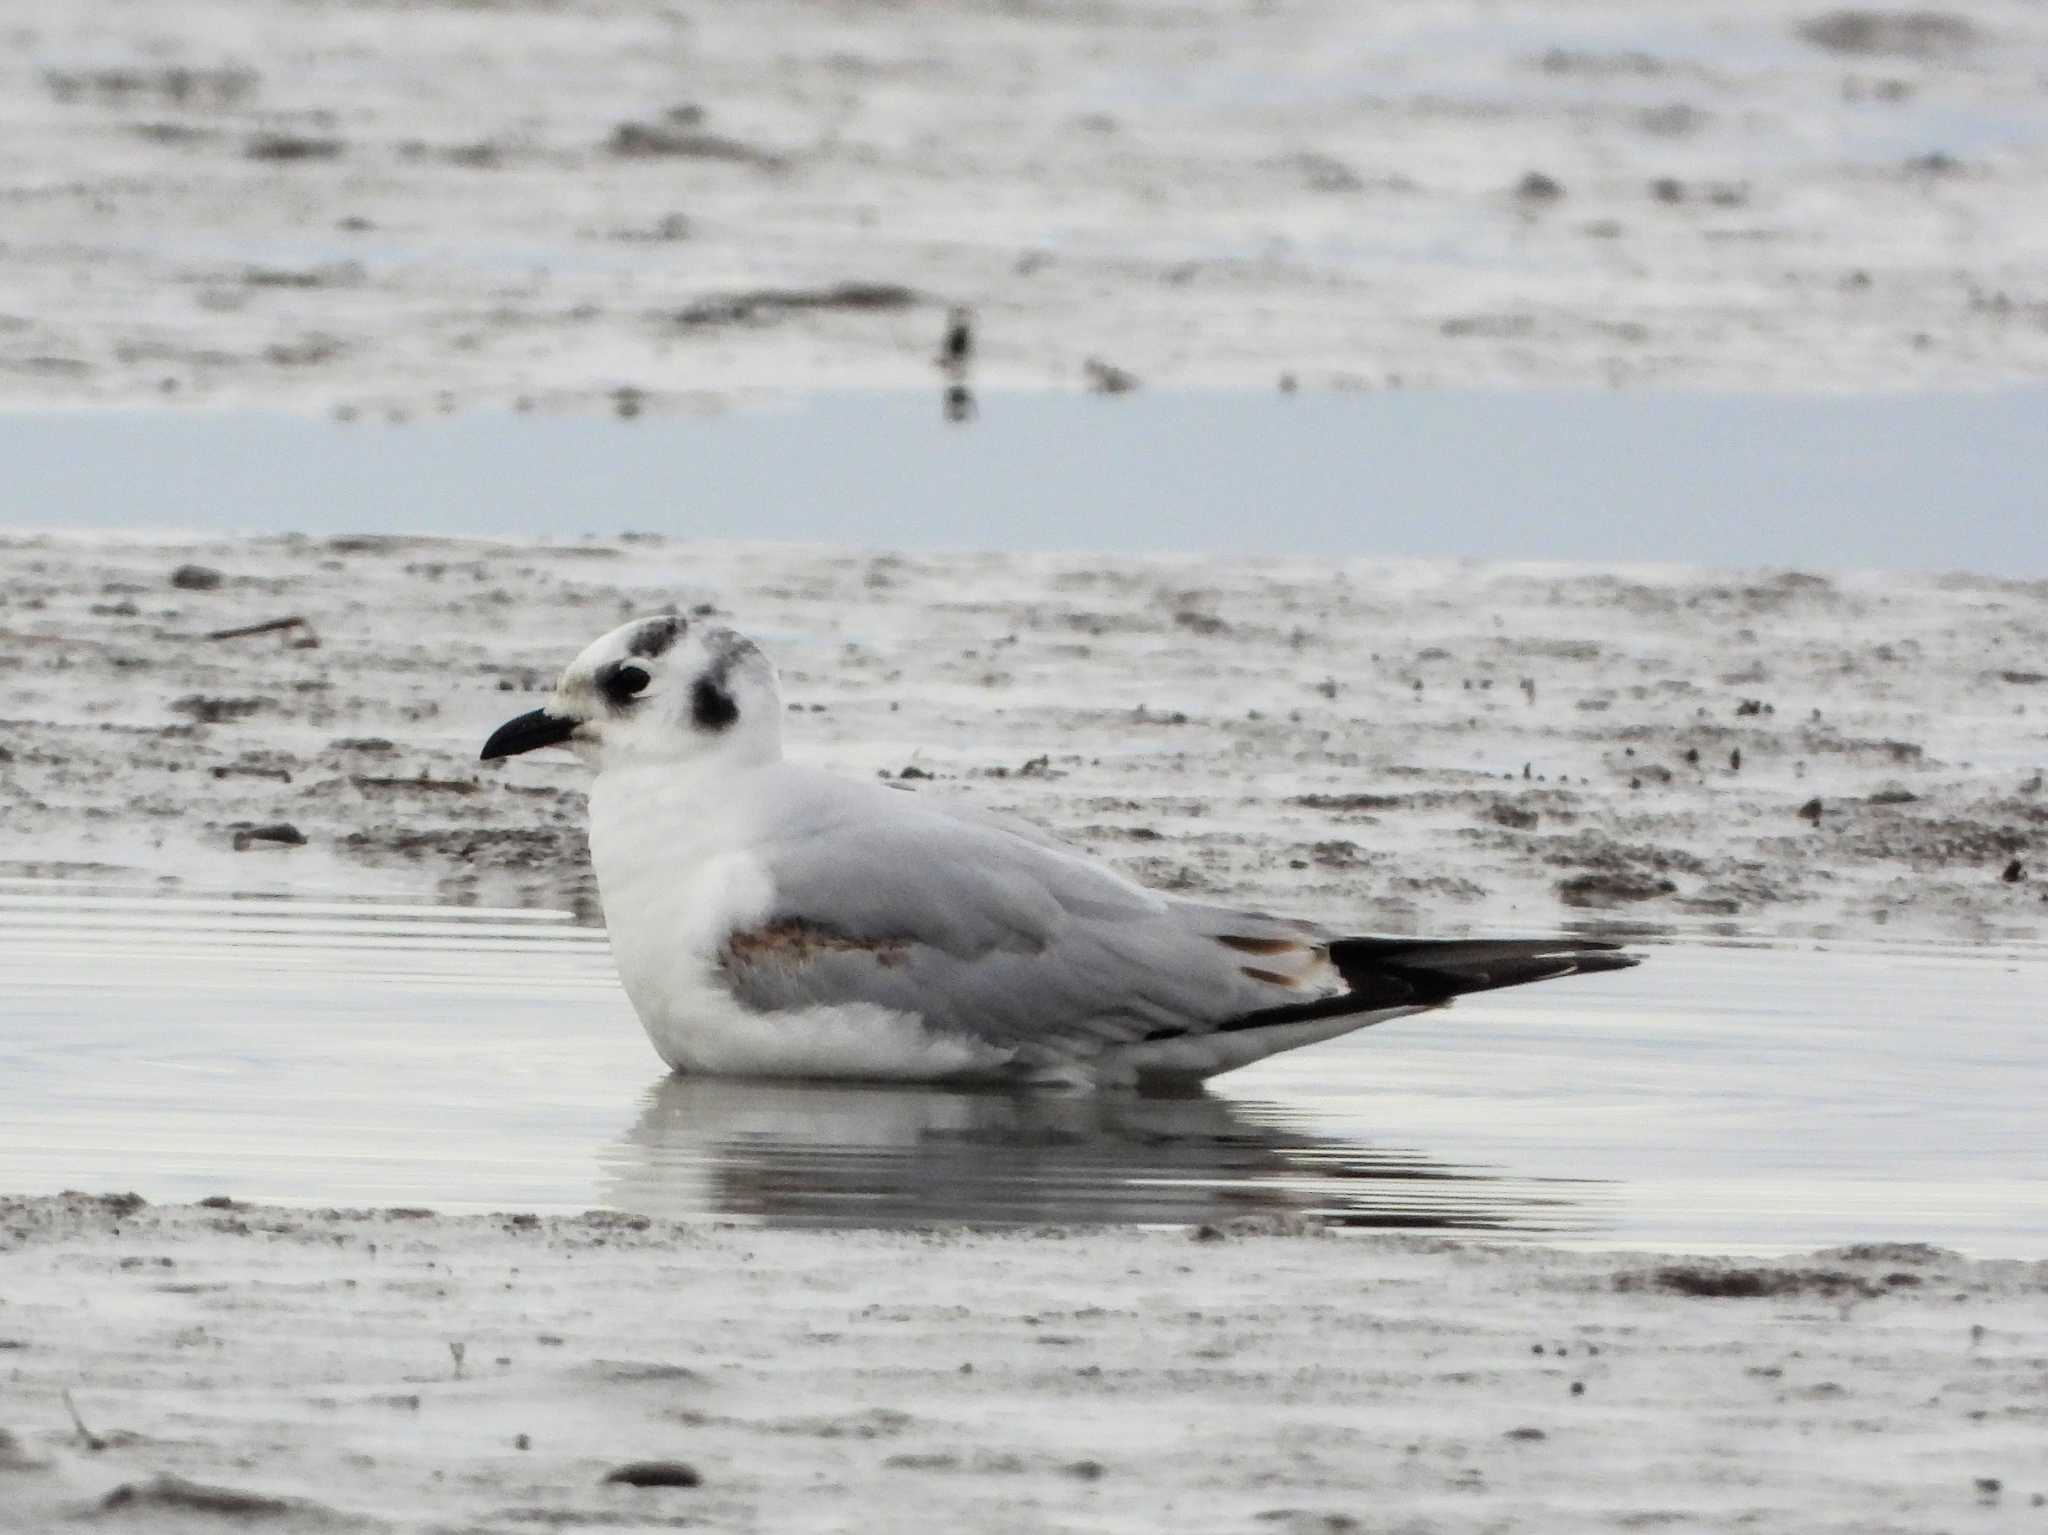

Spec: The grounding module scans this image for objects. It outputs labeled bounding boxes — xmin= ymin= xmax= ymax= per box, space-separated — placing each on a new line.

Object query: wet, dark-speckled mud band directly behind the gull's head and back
xmin=0 ymin=534 xmax=2048 ymax=937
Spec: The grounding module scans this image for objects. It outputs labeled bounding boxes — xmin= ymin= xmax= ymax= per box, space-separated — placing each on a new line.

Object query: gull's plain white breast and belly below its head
xmin=590 ymin=765 xmax=1010 ymax=1081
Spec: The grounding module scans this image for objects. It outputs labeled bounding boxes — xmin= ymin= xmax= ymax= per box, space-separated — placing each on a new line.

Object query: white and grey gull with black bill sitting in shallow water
xmin=483 ymin=612 xmax=1634 ymax=1089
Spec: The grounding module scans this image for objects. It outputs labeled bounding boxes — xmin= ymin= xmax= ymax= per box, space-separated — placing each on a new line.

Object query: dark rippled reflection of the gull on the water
xmin=602 ymin=1077 xmax=1591 ymax=1232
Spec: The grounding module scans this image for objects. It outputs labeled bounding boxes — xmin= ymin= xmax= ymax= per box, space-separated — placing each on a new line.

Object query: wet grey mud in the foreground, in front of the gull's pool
xmin=0 ymin=1195 xmax=2048 ymax=1535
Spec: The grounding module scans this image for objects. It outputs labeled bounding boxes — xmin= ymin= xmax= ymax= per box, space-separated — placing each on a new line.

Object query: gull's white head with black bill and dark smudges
xmin=483 ymin=612 xmax=782 ymax=772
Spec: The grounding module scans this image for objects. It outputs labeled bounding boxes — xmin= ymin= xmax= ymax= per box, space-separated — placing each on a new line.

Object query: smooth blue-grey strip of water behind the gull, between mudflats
xmin=16 ymin=385 xmax=2048 ymax=579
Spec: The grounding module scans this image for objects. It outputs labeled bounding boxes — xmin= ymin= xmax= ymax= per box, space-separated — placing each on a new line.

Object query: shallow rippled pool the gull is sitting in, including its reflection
xmin=0 ymin=880 xmax=2048 ymax=1255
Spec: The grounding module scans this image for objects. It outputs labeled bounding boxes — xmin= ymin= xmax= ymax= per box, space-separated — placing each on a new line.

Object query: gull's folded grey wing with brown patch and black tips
xmin=721 ymin=776 xmax=1634 ymax=1058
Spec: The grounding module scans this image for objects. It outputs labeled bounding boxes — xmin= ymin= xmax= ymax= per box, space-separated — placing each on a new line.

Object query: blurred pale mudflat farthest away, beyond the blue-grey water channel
xmin=12 ymin=0 xmax=2048 ymax=415
